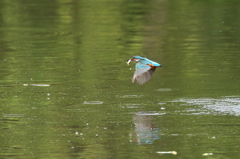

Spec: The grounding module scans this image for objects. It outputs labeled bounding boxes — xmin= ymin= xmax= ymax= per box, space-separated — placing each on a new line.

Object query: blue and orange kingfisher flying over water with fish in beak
xmin=127 ymin=56 xmax=162 ymax=85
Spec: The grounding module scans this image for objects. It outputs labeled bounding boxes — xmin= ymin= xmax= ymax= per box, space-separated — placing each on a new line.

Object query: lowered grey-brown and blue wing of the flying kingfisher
xmin=132 ymin=62 xmax=154 ymax=85
